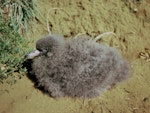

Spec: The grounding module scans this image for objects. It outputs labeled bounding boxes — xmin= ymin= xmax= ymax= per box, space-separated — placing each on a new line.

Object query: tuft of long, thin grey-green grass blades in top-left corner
xmin=0 ymin=0 xmax=37 ymax=33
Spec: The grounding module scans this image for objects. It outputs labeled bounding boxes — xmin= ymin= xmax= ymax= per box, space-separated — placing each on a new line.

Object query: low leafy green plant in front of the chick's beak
xmin=0 ymin=16 xmax=29 ymax=82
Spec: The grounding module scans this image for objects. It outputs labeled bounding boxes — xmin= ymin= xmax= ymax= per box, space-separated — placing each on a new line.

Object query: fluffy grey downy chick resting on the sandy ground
xmin=26 ymin=35 xmax=129 ymax=98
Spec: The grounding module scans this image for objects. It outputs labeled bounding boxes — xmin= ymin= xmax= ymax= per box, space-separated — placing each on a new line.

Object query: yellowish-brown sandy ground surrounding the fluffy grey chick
xmin=0 ymin=0 xmax=150 ymax=113
